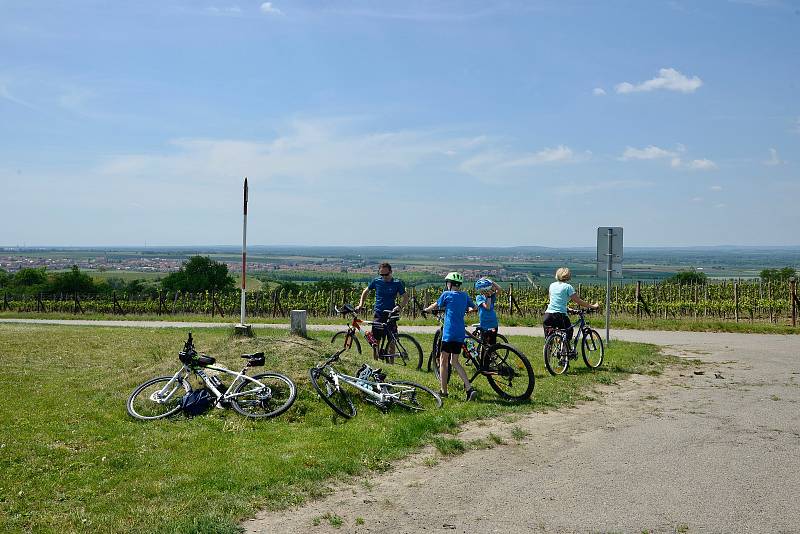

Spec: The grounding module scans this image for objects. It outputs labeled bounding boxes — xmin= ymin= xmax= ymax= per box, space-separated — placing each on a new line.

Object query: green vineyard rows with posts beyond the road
xmin=0 ymin=280 xmax=800 ymax=323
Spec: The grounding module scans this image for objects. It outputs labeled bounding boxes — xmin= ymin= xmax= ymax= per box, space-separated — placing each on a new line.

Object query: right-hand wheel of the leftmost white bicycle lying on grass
xmin=231 ymin=373 xmax=297 ymax=418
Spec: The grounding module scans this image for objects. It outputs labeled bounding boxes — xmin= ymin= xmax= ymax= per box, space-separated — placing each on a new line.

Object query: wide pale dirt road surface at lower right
xmin=243 ymin=331 xmax=800 ymax=533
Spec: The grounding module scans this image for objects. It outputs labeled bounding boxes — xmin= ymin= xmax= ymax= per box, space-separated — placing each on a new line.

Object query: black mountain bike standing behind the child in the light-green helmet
xmin=428 ymin=310 xmax=536 ymax=401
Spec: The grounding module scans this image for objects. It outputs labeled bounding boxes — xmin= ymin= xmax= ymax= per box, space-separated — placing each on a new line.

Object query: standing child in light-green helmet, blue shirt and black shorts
xmin=425 ymin=272 xmax=478 ymax=401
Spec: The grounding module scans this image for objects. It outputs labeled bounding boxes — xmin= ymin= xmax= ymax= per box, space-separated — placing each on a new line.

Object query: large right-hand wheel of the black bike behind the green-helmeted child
xmin=484 ymin=343 xmax=536 ymax=400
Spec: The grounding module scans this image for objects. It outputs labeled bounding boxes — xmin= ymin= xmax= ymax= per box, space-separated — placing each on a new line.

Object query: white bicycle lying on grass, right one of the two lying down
xmin=309 ymin=347 xmax=442 ymax=419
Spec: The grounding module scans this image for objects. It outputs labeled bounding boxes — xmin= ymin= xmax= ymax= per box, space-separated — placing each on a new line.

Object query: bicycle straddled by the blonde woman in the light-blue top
xmin=544 ymin=308 xmax=605 ymax=376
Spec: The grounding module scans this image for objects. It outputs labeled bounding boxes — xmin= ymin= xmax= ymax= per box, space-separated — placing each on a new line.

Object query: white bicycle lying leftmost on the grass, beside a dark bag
xmin=126 ymin=333 xmax=297 ymax=421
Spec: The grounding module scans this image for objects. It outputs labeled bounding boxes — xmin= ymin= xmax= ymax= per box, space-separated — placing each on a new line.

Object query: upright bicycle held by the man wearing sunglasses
xmin=331 ymin=304 xmax=423 ymax=369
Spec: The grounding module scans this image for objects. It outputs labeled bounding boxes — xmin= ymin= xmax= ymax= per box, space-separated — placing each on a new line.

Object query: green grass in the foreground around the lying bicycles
xmin=0 ymin=324 xmax=668 ymax=533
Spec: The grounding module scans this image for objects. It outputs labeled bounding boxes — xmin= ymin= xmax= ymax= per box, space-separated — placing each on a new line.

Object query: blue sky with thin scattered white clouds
xmin=0 ymin=0 xmax=800 ymax=247
